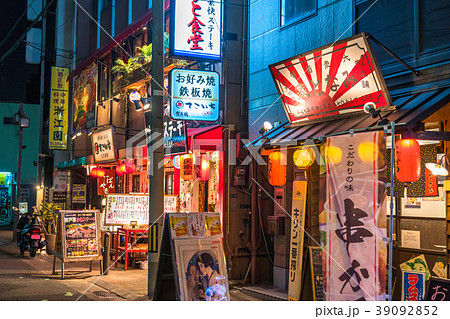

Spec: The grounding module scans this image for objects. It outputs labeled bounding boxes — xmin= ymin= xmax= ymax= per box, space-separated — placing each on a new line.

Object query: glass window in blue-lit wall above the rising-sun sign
xmin=280 ymin=0 xmax=317 ymax=26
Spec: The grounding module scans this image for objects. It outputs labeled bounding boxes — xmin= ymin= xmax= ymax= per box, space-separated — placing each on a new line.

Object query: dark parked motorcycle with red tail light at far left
xmin=17 ymin=214 xmax=47 ymax=257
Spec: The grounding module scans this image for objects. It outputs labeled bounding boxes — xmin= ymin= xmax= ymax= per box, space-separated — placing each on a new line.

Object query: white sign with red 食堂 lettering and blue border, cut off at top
xmin=170 ymin=0 xmax=222 ymax=60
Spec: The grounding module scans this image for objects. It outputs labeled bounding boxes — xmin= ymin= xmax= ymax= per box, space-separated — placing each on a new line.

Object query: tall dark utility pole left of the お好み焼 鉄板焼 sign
xmin=148 ymin=0 xmax=164 ymax=297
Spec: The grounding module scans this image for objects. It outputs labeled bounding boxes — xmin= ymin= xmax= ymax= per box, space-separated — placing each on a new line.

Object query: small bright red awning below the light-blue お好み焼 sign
xmin=186 ymin=125 xmax=223 ymax=151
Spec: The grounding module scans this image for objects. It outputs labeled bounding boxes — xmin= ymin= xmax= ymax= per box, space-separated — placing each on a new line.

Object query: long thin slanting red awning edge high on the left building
xmin=67 ymin=0 xmax=170 ymax=81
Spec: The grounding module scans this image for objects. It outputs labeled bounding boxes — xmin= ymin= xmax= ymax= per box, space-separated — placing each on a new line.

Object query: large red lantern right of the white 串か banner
xmin=395 ymin=139 xmax=420 ymax=183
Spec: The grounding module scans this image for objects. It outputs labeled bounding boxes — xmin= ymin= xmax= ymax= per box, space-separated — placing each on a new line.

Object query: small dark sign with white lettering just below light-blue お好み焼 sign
xmin=163 ymin=108 xmax=187 ymax=155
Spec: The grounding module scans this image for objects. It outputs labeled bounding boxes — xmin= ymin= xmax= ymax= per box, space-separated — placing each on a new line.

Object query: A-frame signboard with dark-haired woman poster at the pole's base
xmin=154 ymin=213 xmax=230 ymax=301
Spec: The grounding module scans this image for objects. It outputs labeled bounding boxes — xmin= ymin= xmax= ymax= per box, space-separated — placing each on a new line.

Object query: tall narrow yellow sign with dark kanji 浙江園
xmin=48 ymin=66 xmax=69 ymax=150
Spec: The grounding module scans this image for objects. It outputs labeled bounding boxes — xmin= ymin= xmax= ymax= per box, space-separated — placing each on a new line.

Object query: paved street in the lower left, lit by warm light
xmin=0 ymin=226 xmax=257 ymax=301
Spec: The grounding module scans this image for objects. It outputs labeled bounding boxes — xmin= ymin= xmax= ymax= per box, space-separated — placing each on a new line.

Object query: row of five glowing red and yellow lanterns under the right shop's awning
xmin=269 ymin=139 xmax=421 ymax=186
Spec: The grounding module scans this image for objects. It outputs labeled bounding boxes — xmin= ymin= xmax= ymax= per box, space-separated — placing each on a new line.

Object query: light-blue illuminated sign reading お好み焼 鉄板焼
xmin=170 ymin=69 xmax=220 ymax=122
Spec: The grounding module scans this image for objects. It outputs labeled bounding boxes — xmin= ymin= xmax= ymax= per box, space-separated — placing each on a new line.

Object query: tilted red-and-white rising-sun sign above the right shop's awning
xmin=269 ymin=33 xmax=391 ymax=124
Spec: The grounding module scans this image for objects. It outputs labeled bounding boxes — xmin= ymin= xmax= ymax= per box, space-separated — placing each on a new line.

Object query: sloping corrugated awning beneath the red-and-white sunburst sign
xmin=246 ymin=85 xmax=450 ymax=147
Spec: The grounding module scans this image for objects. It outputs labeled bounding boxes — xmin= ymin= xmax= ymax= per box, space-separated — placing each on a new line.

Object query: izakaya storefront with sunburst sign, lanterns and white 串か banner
xmin=249 ymin=36 xmax=450 ymax=301
